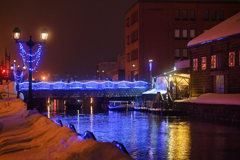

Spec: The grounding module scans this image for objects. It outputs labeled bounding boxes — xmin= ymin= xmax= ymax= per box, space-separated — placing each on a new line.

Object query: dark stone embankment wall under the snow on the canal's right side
xmin=173 ymin=102 xmax=240 ymax=122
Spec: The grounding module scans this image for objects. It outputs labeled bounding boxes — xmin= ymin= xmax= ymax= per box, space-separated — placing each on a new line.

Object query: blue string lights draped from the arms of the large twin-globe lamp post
xmin=19 ymin=43 xmax=42 ymax=71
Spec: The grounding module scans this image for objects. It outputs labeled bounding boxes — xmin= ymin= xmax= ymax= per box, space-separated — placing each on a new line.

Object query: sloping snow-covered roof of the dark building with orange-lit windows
xmin=187 ymin=12 xmax=240 ymax=47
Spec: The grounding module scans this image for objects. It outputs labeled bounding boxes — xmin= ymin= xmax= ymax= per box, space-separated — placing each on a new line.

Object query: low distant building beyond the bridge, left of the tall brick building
xmin=95 ymin=62 xmax=118 ymax=80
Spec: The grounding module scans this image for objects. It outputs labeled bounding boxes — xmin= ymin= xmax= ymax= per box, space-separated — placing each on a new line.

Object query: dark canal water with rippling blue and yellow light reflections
xmin=41 ymin=102 xmax=240 ymax=160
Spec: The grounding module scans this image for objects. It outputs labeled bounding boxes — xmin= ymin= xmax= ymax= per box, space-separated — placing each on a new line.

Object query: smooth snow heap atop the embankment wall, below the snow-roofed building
xmin=175 ymin=93 xmax=240 ymax=105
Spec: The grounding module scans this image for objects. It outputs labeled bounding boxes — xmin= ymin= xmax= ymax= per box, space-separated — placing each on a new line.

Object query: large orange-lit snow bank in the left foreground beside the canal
xmin=0 ymin=99 xmax=132 ymax=160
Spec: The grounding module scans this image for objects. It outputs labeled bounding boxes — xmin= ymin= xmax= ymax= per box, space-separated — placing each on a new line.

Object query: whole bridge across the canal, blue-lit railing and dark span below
xmin=19 ymin=80 xmax=148 ymax=99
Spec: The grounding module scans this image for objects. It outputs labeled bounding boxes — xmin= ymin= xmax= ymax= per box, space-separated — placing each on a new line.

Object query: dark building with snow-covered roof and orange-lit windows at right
xmin=188 ymin=12 xmax=240 ymax=96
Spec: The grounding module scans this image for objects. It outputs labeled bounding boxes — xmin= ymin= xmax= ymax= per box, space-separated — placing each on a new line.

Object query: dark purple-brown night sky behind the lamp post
xmin=0 ymin=0 xmax=137 ymax=79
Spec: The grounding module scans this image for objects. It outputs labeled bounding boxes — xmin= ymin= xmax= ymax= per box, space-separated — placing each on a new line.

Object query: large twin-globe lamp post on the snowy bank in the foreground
xmin=13 ymin=27 xmax=48 ymax=110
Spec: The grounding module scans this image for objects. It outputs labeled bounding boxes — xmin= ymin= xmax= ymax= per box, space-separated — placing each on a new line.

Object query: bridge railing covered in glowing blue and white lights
xmin=19 ymin=81 xmax=148 ymax=91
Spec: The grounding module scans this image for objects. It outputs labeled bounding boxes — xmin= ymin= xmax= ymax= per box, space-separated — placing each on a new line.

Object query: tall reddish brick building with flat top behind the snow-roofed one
xmin=125 ymin=0 xmax=240 ymax=81
